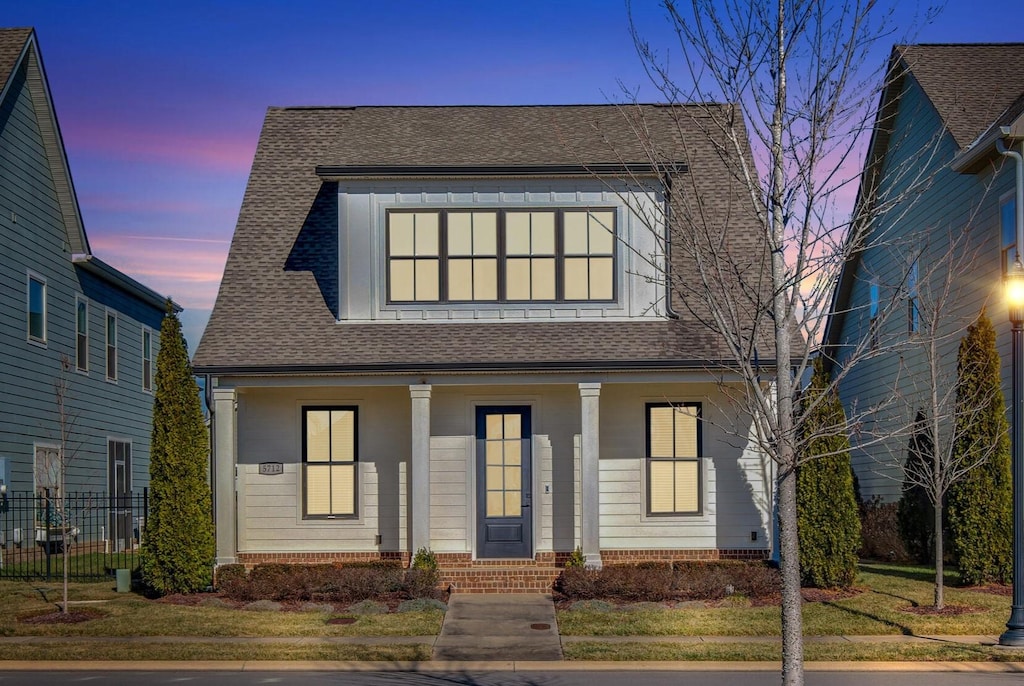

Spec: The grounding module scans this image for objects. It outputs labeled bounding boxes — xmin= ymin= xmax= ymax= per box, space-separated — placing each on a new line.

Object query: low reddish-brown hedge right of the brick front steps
xmin=554 ymin=561 xmax=781 ymax=602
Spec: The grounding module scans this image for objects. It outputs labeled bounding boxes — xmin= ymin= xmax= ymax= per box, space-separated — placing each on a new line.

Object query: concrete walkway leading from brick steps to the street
xmin=433 ymin=593 xmax=562 ymax=661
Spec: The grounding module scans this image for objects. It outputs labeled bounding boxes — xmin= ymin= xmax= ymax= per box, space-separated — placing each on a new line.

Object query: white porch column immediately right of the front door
xmin=580 ymin=383 xmax=601 ymax=569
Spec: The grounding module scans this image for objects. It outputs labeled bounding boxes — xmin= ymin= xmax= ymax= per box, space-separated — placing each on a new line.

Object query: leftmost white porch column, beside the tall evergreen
xmin=213 ymin=388 xmax=238 ymax=564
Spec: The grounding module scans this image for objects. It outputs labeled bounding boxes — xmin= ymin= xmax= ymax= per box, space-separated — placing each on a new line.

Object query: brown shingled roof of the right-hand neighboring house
xmin=896 ymin=43 xmax=1024 ymax=149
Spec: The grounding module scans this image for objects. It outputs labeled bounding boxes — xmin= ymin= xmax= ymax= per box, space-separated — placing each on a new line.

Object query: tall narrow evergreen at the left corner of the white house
xmin=142 ymin=301 xmax=215 ymax=594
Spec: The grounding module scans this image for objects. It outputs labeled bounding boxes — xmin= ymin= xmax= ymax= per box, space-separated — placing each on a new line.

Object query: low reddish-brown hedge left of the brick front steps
xmin=217 ymin=560 xmax=439 ymax=603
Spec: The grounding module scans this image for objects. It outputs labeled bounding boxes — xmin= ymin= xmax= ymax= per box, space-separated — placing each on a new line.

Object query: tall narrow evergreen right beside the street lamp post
xmin=948 ymin=311 xmax=1013 ymax=584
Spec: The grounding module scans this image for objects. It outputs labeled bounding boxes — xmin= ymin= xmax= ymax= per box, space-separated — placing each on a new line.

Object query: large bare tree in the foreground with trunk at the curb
xmin=624 ymin=0 xmax=936 ymax=684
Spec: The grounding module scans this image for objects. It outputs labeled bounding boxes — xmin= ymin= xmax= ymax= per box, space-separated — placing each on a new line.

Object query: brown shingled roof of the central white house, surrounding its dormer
xmin=194 ymin=105 xmax=772 ymax=373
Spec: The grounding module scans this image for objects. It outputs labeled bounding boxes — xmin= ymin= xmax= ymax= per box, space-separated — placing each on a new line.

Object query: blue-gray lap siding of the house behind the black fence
xmin=0 ymin=52 xmax=163 ymax=492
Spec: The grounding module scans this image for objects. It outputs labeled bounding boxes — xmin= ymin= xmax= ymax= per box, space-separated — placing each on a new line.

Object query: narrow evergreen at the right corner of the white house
xmin=797 ymin=358 xmax=860 ymax=588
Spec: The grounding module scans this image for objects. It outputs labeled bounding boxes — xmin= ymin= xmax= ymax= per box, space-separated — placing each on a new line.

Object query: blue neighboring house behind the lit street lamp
xmin=825 ymin=43 xmax=1024 ymax=500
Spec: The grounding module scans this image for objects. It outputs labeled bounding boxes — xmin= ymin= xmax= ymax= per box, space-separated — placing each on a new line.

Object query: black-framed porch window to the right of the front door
xmin=647 ymin=402 xmax=701 ymax=515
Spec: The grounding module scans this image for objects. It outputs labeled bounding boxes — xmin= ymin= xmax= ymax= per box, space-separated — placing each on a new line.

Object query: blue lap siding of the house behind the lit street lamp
xmin=838 ymin=71 xmax=1014 ymax=501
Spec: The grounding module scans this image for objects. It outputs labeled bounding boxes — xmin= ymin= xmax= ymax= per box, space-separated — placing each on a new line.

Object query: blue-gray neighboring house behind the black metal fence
xmin=0 ymin=29 xmax=172 ymax=522
